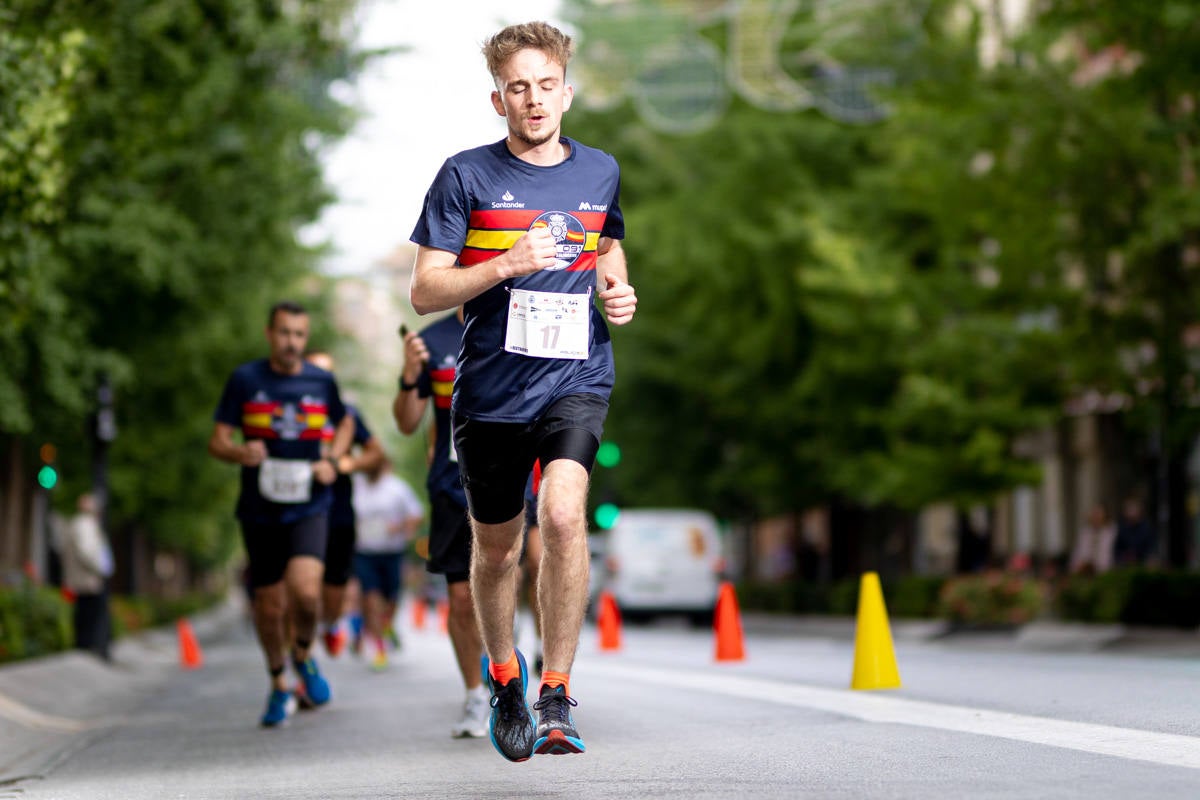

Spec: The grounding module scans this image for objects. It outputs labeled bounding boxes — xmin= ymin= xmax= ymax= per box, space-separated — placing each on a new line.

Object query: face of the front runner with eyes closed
xmin=492 ymin=49 xmax=575 ymax=148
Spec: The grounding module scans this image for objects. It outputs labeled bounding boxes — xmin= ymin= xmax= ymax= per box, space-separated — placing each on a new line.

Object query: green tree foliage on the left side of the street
xmin=0 ymin=0 xmax=361 ymax=573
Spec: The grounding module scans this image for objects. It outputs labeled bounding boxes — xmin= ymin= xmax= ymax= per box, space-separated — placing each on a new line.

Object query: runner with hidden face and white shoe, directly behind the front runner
xmin=391 ymin=308 xmax=488 ymax=738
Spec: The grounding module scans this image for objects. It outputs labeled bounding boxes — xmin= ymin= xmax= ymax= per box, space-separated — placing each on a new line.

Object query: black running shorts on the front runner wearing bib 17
xmin=454 ymin=395 xmax=608 ymax=525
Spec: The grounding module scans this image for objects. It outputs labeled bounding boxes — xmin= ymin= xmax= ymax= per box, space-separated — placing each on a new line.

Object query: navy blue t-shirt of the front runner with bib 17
xmin=412 ymin=137 xmax=625 ymax=422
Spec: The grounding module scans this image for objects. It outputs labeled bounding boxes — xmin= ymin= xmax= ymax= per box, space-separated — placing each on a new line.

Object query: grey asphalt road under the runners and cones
xmin=0 ymin=604 xmax=1200 ymax=800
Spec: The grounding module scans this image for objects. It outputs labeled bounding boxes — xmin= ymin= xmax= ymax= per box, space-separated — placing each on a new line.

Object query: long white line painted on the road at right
xmin=589 ymin=663 xmax=1200 ymax=769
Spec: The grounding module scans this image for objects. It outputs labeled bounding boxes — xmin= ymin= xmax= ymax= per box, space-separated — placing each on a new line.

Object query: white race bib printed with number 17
xmin=504 ymin=289 xmax=592 ymax=361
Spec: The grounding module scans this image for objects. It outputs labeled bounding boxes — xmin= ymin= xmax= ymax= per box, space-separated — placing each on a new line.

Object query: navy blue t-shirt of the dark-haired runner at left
xmin=212 ymin=359 xmax=346 ymax=523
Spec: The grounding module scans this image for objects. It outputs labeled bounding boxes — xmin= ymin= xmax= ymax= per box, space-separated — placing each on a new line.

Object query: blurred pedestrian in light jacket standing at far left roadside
xmin=59 ymin=492 xmax=113 ymax=661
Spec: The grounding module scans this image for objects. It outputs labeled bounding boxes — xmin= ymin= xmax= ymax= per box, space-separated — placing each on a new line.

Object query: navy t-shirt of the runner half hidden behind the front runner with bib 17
xmin=416 ymin=314 xmax=467 ymax=509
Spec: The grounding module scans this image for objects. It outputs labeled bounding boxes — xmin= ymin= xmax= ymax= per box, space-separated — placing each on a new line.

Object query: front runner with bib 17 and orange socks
xmin=410 ymin=23 xmax=637 ymax=762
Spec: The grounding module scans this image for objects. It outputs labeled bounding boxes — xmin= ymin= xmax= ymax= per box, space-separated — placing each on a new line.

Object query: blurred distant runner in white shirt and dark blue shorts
xmin=353 ymin=458 xmax=425 ymax=669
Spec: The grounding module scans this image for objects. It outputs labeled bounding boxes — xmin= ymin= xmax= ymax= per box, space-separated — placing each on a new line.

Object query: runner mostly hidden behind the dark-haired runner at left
xmin=305 ymin=350 xmax=384 ymax=658
